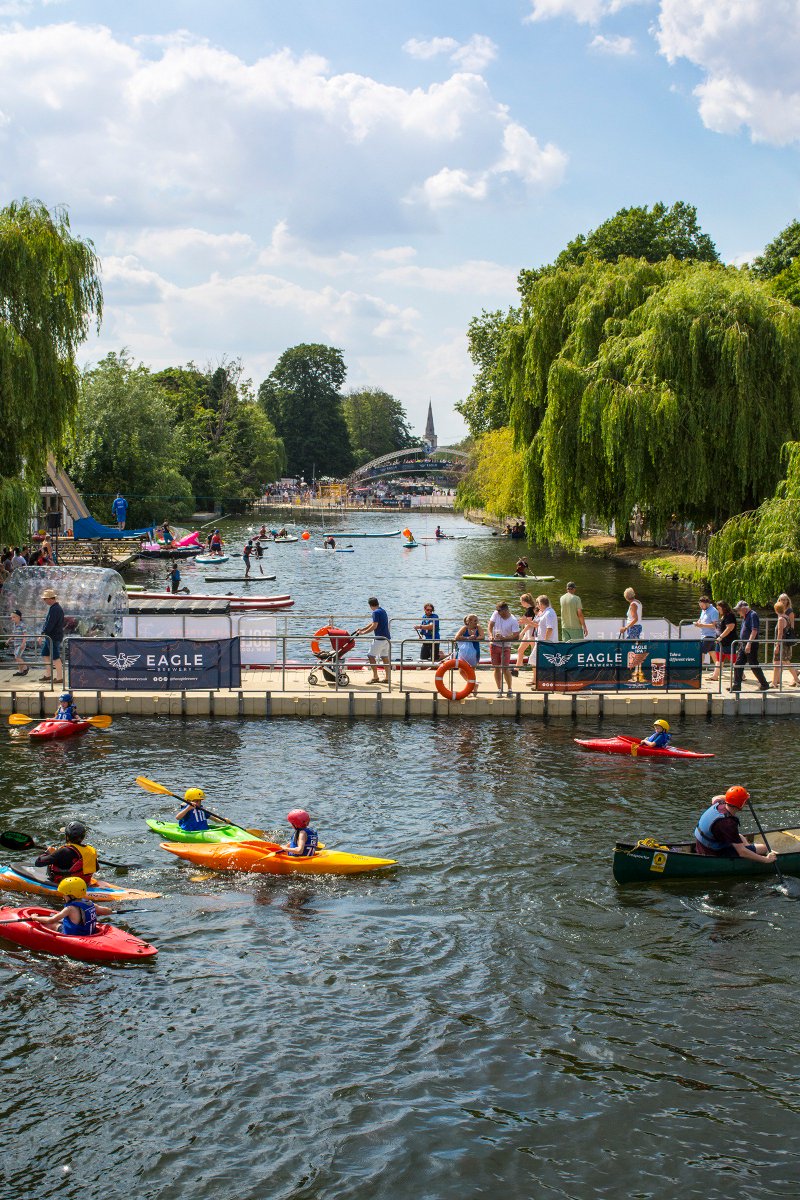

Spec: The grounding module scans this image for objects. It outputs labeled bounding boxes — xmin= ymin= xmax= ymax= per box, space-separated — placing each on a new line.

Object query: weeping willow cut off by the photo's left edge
xmin=0 ymin=200 xmax=102 ymax=539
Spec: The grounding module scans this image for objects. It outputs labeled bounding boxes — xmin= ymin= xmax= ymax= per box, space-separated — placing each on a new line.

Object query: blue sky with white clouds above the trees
xmin=0 ymin=0 xmax=800 ymax=443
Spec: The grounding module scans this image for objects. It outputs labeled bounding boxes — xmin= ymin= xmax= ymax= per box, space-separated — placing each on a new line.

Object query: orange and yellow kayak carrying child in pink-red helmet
xmin=161 ymin=841 xmax=397 ymax=875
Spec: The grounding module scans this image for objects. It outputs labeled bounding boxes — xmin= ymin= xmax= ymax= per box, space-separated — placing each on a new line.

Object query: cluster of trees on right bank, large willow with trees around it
xmin=456 ymin=202 xmax=800 ymax=600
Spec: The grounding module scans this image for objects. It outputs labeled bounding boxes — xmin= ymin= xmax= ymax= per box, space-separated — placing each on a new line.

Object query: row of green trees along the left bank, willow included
xmin=0 ymin=200 xmax=419 ymax=541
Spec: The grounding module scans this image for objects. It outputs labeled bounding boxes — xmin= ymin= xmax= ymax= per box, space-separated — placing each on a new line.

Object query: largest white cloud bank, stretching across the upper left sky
xmin=0 ymin=24 xmax=560 ymax=240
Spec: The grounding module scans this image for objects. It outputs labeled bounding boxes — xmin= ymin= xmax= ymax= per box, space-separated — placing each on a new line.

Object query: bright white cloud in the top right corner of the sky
xmin=656 ymin=0 xmax=800 ymax=145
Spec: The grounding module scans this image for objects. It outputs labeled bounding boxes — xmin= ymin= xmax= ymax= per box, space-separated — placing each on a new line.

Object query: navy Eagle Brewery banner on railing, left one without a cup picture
xmin=65 ymin=637 xmax=241 ymax=691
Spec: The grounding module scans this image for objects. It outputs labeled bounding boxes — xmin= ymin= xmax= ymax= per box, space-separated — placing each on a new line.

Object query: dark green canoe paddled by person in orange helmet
xmin=613 ymin=829 xmax=800 ymax=883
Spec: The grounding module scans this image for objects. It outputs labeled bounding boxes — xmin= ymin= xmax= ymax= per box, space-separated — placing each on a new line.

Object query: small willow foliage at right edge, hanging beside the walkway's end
xmin=709 ymin=442 xmax=800 ymax=605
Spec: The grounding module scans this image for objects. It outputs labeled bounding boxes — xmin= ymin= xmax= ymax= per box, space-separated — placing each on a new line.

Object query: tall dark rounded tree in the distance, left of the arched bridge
xmin=258 ymin=344 xmax=353 ymax=480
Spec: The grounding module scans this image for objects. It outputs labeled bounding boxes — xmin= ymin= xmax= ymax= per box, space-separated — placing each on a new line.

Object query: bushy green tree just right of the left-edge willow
xmin=68 ymin=353 xmax=194 ymax=527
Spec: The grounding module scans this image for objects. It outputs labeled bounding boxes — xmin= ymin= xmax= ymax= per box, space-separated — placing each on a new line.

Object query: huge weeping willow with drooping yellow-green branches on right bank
xmin=503 ymin=258 xmax=800 ymax=542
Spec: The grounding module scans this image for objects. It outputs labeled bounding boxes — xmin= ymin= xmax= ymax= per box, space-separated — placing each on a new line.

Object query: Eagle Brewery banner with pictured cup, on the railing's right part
xmin=536 ymin=638 xmax=703 ymax=691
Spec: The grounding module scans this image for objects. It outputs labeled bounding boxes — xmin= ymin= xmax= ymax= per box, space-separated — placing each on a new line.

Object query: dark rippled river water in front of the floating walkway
xmin=0 ymin=720 xmax=800 ymax=1200
